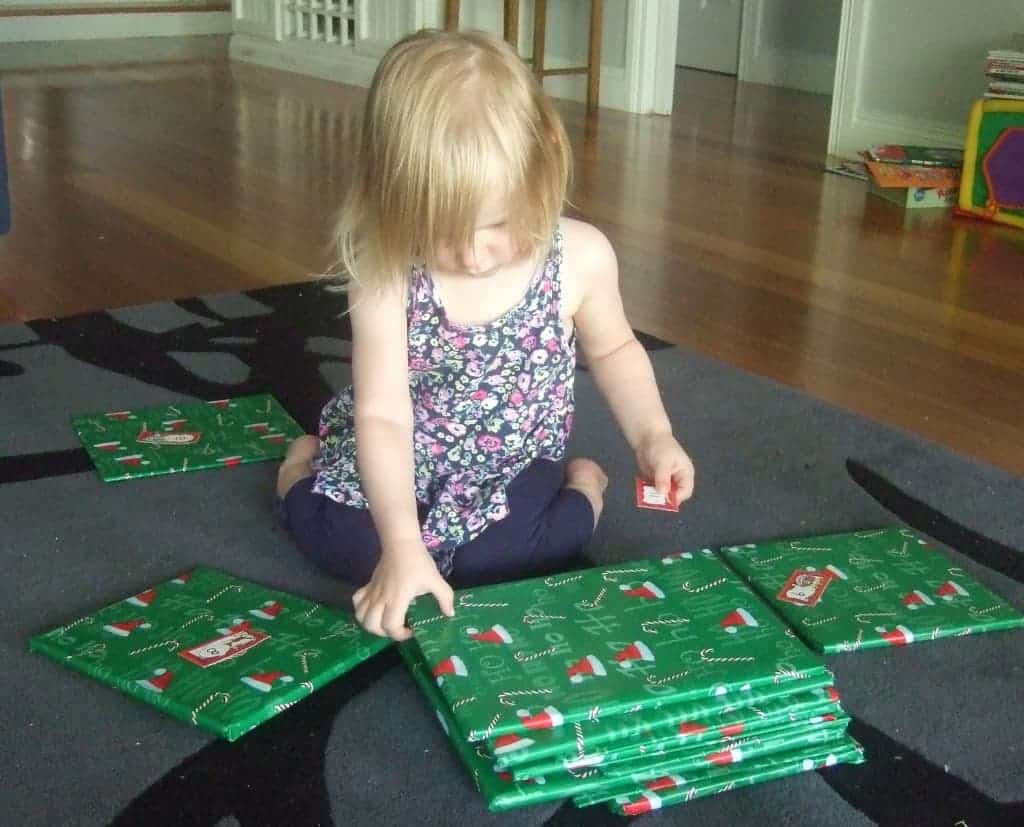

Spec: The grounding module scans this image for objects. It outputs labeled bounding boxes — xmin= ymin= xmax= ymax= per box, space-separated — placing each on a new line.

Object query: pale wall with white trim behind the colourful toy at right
xmin=829 ymin=0 xmax=1024 ymax=155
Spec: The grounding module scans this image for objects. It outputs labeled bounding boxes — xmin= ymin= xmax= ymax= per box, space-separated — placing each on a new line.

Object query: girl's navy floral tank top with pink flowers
xmin=313 ymin=228 xmax=575 ymax=574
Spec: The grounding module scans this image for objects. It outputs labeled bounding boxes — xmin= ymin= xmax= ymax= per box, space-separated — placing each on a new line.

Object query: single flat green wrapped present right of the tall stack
xmin=722 ymin=527 xmax=1024 ymax=654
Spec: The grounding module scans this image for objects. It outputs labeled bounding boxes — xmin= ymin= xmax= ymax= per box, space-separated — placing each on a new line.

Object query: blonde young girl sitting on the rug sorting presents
xmin=278 ymin=32 xmax=693 ymax=640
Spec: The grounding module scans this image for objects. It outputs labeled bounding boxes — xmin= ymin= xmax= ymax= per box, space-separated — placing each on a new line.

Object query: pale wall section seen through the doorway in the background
xmin=739 ymin=0 xmax=843 ymax=94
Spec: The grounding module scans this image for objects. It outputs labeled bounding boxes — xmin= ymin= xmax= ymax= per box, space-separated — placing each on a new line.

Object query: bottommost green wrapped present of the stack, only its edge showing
xmin=573 ymin=735 xmax=864 ymax=816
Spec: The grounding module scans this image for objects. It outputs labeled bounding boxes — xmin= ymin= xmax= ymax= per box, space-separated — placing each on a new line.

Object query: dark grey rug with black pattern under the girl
xmin=0 ymin=286 xmax=1024 ymax=827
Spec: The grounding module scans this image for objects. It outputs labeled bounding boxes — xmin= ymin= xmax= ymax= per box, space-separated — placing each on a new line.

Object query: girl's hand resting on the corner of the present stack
xmin=352 ymin=539 xmax=455 ymax=641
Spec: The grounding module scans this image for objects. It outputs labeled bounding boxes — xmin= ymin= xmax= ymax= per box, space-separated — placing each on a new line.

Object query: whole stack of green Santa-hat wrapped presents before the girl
xmin=400 ymin=550 xmax=863 ymax=815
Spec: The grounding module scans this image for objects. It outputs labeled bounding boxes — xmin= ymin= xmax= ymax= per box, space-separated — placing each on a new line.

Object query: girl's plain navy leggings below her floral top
xmin=282 ymin=460 xmax=594 ymax=587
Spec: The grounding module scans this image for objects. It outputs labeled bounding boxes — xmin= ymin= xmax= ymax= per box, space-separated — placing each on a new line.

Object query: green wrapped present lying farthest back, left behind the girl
xmin=72 ymin=393 xmax=303 ymax=482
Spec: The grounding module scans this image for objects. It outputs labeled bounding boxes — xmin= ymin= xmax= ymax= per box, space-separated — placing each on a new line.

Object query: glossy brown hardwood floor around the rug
xmin=0 ymin=38 xmax=1024 ymax=474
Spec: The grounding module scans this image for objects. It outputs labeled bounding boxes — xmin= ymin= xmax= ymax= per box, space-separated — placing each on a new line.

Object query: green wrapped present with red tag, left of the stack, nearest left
xmin=29 ymin=568 xmax=389 ymax=741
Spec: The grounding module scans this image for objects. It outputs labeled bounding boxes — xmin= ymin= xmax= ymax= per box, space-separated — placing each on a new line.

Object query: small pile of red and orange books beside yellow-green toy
xmin=863 ymin=143 xmax=964 ymax=209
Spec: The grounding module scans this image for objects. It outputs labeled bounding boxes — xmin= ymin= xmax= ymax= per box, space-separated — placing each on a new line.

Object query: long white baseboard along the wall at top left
xmin=0 ymin=11 xmax=231 ymax=43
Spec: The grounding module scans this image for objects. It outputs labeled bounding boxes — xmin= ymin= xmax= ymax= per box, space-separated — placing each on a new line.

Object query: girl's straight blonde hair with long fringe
xmin=337 ymin=30 xmax=571 ymax=289
